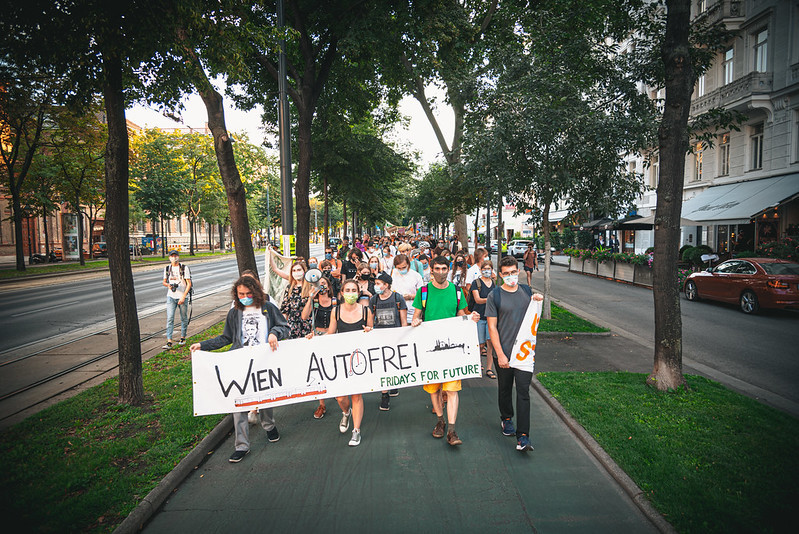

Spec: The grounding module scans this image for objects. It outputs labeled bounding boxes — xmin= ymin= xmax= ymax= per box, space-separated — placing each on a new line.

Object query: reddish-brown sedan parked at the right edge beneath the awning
xmin=683 ymin=258 xmax=799 ymax=313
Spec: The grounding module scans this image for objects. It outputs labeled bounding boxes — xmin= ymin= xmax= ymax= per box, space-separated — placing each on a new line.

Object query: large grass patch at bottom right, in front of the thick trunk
xmin=538 ymin=372 xmax=799 ymax=533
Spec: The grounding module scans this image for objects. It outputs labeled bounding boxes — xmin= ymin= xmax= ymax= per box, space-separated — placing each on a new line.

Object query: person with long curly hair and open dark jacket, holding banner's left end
xmin=189 ymin=276 xmax=289 ymax=463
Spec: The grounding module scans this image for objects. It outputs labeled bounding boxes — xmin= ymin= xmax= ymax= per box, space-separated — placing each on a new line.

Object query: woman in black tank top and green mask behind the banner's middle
xmin=306 ymin=280 xmax=374 ymax=447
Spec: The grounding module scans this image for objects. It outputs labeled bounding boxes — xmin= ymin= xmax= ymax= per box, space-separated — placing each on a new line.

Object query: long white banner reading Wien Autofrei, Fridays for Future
xmin=191 ymin=315 xmax=481 ymax=415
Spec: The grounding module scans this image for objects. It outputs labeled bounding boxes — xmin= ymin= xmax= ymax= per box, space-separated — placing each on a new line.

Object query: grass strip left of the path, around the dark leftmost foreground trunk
xmin=0 ymin=323 xmax=223 ymax=532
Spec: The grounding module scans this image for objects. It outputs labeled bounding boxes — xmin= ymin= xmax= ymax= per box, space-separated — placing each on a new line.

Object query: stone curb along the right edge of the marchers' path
xmin=531 ymin=376 xmax=677 ymax=534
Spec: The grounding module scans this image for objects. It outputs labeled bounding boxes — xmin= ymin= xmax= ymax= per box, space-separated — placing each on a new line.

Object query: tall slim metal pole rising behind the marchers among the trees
xmin=277 ymin=0 xmax=294 ymax=256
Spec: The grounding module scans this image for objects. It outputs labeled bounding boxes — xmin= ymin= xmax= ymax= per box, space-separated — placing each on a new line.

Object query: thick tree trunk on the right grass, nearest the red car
xmin=646 ymin=0 xmax=695 ymax=391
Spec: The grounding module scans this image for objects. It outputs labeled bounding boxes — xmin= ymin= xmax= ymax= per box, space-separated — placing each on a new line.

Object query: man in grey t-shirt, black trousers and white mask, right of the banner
xmin=486 ymin=256 xmax=544 ymax=452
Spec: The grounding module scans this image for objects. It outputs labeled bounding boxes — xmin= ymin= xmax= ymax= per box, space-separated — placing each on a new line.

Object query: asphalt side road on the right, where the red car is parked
xmin=533 ymin=265 xmax=799 ymax=410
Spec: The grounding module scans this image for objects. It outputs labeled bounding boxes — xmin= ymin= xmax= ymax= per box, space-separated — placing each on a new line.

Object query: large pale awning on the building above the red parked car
xmin=682 ymin=173 xmax=799 ymax=224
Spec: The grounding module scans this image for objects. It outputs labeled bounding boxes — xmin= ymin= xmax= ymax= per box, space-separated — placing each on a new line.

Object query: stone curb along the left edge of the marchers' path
xmin=114 ymin=414 xmax=233 ymax=534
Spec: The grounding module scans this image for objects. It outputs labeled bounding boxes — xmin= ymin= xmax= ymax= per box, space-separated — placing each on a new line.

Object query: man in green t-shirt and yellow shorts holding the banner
xmin=411 ymin=256 xmax=480 ymax=445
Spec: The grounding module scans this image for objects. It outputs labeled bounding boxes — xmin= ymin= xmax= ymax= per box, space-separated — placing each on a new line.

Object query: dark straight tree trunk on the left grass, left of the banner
xmin=103 ymin=50 xmax=144 ymax=405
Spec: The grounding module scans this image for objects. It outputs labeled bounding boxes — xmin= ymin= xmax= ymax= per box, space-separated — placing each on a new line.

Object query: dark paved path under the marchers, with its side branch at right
xmin=134 ymin=336 xmax=668 ymax=533
